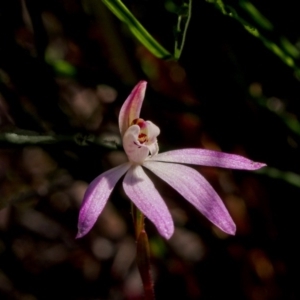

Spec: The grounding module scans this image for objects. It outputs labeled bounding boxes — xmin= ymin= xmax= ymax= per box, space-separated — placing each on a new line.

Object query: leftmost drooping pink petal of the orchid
xmin=76 ymin=163 xmax=130 ymax=238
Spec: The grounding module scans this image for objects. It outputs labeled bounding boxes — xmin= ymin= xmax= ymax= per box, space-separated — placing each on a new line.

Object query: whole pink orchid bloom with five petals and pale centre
xmin=77 ymin=81 xmax=265 ymax=239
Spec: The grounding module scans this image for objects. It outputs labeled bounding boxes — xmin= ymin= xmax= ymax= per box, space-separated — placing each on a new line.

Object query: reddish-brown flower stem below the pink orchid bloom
xmin=131 ymin=203 xmax=155 ymax=300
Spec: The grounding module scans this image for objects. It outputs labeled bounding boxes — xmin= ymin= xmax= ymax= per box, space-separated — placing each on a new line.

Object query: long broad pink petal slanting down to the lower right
xmin=143 ymin=161 xmax=236 ymax=234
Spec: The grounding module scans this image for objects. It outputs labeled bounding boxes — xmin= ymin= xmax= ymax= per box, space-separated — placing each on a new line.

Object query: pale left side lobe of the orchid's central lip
xmin=123 ymin=125 xmax=149 ymax=163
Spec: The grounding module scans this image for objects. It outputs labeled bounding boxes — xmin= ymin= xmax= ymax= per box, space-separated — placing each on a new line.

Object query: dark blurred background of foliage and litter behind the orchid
xmin=0 ymin=0 xmax=300 ymax=300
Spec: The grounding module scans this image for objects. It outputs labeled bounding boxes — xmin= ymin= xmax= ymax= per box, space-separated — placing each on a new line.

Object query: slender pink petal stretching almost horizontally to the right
xmin=149 ymin=149 xmax=266 ymax=170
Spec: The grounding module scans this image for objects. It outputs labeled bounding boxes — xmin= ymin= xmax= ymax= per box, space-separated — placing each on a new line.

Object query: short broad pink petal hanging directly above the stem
xmin=123 ymin=165 xmax=174 ymax=239
